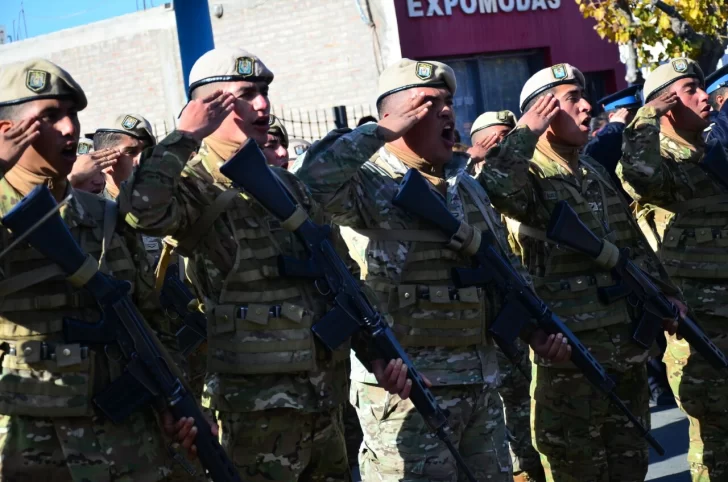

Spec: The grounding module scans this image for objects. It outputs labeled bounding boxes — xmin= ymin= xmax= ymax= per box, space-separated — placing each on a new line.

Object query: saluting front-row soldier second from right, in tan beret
xmin=478 ymin=64 xmax=677 ymax=482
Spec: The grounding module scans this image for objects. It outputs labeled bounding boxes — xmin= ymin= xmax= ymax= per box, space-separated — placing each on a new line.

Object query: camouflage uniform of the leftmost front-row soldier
xmin=0 ymin=172 xmax=170 ymax=482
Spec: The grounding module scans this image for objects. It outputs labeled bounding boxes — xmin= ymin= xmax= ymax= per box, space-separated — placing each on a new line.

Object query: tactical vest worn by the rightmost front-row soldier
xmin=637 ymin=136 xmax=728 ymax=279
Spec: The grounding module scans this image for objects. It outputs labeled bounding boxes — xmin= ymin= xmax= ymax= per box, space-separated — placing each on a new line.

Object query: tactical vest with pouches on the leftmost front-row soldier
xmin=0 ymin=179 xmax=145 ymax=417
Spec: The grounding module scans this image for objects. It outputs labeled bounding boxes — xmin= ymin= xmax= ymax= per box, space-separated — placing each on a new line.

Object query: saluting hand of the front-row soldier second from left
xmin=177 ymin=90 xmax=235 ymax=142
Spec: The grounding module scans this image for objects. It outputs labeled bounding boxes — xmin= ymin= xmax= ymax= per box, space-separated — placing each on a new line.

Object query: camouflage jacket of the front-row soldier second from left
xmin=120 ymin=132 xmax=346 ymax=412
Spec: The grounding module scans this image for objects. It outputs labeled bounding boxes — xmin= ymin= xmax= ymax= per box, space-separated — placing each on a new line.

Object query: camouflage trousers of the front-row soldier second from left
xmin=217 ymin=407 xmax=351 ymax=482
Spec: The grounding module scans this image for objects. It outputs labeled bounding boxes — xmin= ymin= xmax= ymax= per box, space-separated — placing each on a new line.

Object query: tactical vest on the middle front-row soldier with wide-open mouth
xmin=341 ymin=154 xmax=505 ymax=347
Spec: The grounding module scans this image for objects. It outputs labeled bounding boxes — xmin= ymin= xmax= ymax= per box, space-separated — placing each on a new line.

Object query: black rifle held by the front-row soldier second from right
xmin=546 ymin=201 xmax=728 ymax=369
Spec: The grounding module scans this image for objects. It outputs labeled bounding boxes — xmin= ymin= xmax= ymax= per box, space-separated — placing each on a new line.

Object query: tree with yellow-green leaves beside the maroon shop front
xmin=576 ymin=0 xmax=728 ymax=82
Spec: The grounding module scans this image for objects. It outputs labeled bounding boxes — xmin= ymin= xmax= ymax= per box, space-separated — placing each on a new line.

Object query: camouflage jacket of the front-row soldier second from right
xmin=478 ymin=127 xmax=672 ymax=371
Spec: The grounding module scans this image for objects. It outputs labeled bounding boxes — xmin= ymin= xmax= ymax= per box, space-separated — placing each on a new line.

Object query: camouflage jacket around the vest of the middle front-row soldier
xmin=293 ymin=124 xmax=536 ymax=385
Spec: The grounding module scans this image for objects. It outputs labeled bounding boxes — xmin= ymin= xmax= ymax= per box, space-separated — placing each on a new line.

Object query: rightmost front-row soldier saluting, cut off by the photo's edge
xmin=620 ymin=58 xmax=728 ymax=482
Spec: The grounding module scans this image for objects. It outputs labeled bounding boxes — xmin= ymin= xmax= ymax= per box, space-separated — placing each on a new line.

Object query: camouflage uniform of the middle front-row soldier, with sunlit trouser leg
xmin=293 ymin=124 xmax=512 ymax=482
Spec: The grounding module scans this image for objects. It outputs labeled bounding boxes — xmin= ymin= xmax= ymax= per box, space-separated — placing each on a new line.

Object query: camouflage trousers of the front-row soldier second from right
xmin=531 ymin=364 xmax=650 ymax=482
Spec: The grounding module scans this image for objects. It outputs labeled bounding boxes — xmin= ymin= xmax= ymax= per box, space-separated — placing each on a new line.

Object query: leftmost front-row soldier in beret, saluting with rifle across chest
xmin=0 ymin=59 xmax=209 ymax=481
